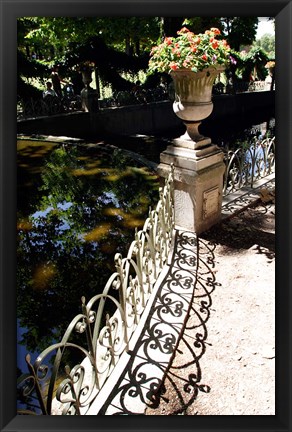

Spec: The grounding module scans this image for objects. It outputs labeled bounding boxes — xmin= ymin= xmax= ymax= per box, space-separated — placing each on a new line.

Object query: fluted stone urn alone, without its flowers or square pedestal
xmin=170 ymin=66 xmax=225 ymax=148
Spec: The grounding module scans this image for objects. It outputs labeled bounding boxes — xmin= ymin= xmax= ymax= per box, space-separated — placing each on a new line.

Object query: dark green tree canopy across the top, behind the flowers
xmin=18 ymin=17 xmax=270 ymax=95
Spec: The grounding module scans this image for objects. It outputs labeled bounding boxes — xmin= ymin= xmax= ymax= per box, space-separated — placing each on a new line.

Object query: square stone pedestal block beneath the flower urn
xmin=158 ymin=139 xmax=225 ymax=234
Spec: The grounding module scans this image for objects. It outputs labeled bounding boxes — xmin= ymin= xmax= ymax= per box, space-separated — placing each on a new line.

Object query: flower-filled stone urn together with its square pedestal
xmin=149 ymin=27 xmax=230 ymax=234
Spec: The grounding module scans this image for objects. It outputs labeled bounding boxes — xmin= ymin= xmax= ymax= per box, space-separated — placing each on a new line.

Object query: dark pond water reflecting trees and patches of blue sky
xmin=17 ymin=146 xmax=158 ymax=351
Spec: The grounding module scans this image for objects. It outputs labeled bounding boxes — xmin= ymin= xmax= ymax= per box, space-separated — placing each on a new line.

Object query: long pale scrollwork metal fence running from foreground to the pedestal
xmin=18 ymin=168 xmax=174 ymax=415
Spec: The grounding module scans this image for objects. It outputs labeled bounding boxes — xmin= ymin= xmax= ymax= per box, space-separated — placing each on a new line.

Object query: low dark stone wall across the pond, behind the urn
xmin=17 ymin=91 xmax=275 ymax=139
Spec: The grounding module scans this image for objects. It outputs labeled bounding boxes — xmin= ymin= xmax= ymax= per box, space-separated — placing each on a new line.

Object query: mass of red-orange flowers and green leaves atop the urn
xmin=149 ymin=27 xmax=232 ymax=73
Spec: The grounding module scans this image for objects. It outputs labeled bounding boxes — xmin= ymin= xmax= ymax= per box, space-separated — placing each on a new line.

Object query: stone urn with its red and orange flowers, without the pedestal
xmin=149 ymin=27 xmax=233 ymax=144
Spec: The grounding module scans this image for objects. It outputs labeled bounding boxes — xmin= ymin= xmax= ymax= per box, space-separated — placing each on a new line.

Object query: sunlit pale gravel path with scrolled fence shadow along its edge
xmin=146 ymin=193 xmax=275 ymax=415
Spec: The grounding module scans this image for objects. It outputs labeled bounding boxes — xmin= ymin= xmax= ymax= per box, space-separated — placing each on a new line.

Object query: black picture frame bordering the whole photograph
xmin=0 ymin=0 xmax=292 ymax=432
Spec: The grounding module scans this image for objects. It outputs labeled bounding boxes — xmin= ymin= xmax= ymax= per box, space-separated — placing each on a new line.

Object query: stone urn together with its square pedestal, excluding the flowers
xmin=158 ymin=68 xmax=225 ymax=234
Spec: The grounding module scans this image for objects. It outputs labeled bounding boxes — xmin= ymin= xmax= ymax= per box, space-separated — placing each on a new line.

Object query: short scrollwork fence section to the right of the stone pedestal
xmin=223 ymin=137 xmax=275 ymax=195
